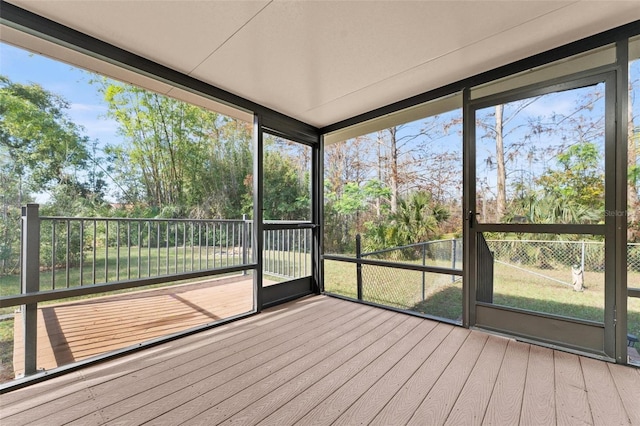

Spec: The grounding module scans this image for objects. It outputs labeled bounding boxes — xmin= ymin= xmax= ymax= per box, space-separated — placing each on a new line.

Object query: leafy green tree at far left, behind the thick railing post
xmin=0 ymin=76 xmax=93 ymax=274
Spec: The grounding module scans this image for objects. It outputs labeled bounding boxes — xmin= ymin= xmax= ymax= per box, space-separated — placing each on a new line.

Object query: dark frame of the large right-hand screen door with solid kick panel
xmin=463 ymin=66 xmax=622 ymax=361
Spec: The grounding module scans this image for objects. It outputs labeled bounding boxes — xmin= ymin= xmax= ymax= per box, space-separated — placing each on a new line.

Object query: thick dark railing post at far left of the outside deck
xmin=20 ymin=204 xmax=40 ymax=376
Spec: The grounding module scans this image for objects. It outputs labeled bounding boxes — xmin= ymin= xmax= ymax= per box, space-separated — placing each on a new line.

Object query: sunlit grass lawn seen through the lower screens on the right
xmin=325 ymin=261 xmax=640 ymax=342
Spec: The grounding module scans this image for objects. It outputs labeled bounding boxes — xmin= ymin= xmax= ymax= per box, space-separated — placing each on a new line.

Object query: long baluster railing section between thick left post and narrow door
xmin=35 ymin=212 xmax=251 ymax=290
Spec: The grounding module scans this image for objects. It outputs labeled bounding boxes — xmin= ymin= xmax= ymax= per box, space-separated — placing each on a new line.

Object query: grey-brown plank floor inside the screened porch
xmin=0 ymin=296 xmax=640 ymax=425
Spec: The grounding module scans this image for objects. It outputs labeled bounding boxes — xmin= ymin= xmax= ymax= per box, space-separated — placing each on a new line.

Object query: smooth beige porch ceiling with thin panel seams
xmin=0 ymin=0 xmax=640 ymax=127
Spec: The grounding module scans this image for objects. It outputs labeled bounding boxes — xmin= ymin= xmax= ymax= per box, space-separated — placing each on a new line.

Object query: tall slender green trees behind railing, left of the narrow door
xmin=100 ymin=79 xmax=252 ymax=218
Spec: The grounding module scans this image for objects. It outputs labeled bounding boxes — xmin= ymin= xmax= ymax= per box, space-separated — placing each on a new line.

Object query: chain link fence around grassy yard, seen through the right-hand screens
xmin=350 ymin=239 xmax=640 ymax=320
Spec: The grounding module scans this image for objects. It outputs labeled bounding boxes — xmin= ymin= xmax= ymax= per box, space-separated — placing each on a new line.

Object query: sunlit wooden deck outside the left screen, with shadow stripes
xmin=13 ymin=275 xmax=260 ymax=376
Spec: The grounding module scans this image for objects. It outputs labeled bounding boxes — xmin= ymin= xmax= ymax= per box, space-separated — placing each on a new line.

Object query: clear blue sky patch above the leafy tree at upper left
xmin=0 ymin=43 xmax=120 ymax=146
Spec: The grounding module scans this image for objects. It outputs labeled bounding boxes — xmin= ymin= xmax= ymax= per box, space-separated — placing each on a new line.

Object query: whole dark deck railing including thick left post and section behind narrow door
xmin=0 ymin=204 xmax=311 ymax=375
